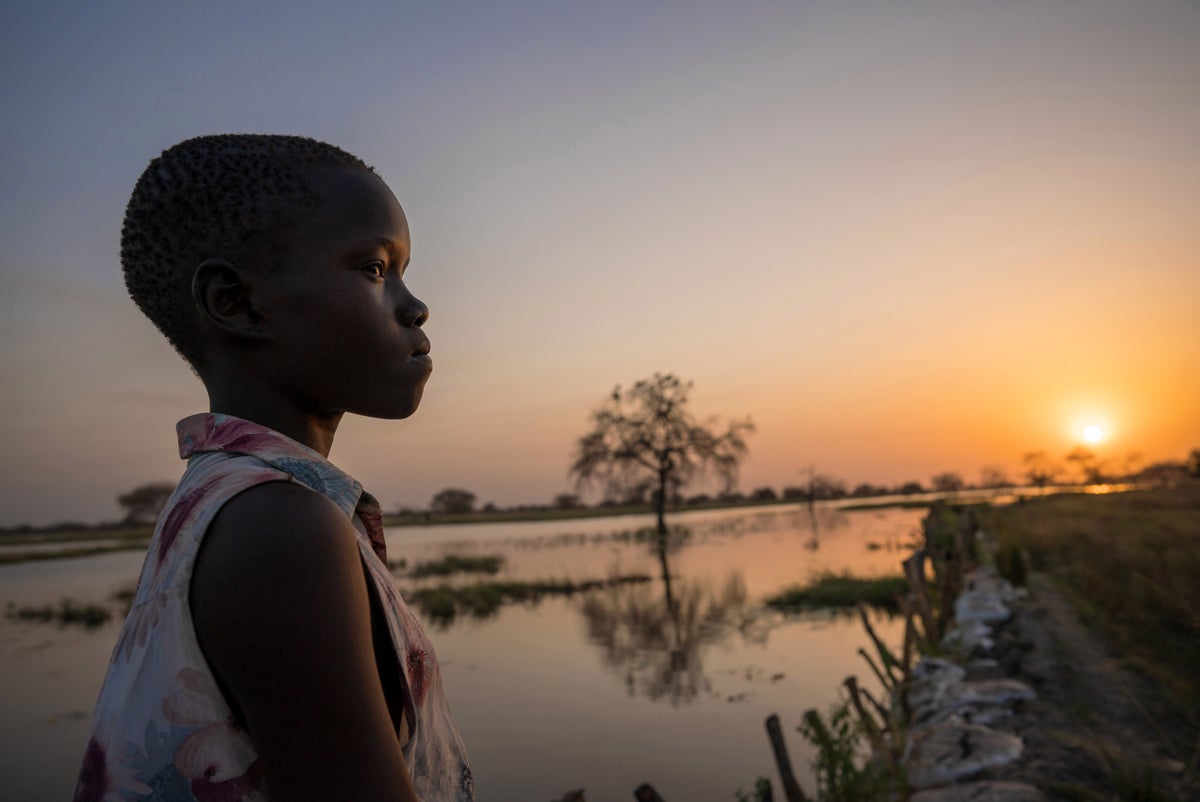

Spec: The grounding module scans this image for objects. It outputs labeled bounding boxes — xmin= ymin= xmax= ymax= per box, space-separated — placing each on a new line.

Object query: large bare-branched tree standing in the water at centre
xmin=570 ymin=373 xmax=754 ymax=534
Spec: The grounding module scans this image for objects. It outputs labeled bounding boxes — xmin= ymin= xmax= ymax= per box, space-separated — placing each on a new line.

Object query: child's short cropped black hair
xmin=121 ymin=133 xmax=376 ymax=369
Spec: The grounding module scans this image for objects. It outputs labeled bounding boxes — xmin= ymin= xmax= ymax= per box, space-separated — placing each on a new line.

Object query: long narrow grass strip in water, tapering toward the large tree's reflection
xmin=404 ymin=574 xmax=650 ymax=627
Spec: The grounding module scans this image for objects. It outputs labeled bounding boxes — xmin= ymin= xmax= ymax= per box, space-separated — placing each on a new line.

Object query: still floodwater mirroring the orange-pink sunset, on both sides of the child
xmin=0 ymin=504 xmax=923 ymax=802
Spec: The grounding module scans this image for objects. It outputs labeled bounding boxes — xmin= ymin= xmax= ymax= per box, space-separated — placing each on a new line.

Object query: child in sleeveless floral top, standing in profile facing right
xmin=74 ymin=134 xmax=474 ymax=802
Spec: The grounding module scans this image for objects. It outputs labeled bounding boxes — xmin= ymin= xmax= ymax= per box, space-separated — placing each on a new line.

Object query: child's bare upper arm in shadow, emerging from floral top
xmin=191 ymin=483 xmax=416 ymax=802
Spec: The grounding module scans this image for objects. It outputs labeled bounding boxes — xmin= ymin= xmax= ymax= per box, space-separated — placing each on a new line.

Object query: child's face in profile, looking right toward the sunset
xmin=259 ymin=168 xmax=433 ymax=418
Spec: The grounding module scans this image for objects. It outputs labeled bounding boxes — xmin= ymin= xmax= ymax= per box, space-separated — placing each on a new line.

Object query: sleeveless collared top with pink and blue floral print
xmin=74 ymin=414 xmax=475 ymax=802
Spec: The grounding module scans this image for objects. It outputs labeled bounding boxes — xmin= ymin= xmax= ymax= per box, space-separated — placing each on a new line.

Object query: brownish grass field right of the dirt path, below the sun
xmin=983 ymin=483 xmax=1200 ymax=741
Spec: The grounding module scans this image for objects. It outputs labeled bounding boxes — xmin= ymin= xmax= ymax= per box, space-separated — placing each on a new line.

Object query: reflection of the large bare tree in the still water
xmin=580 ymin=533 xmax=764 ymax=705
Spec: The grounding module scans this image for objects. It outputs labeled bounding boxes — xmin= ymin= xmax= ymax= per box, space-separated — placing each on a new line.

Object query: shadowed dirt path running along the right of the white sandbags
xmin=988 ymin=574 xmax=1200 ymax=801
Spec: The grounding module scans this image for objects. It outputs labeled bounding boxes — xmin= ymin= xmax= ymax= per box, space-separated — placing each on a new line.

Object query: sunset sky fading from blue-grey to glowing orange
xmin=0 ymin=0 xmax=1200 ymax=525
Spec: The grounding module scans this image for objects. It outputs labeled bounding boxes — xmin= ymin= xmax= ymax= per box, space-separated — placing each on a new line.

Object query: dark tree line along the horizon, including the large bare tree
xmin=9 ymin=398 xmax=1200 ymax=532
